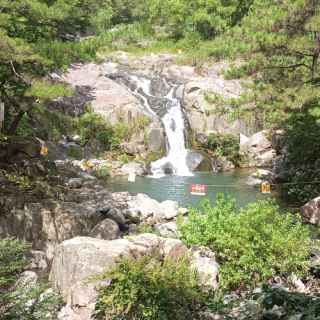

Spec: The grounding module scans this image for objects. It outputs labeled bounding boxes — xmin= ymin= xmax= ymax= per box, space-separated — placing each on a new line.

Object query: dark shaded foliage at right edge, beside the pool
xmin=278 ymin=104 xmax=320 ymax=205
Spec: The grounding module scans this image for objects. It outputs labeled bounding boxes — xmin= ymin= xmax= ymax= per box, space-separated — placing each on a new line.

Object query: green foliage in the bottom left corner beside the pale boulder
xmin=0 ymin=239 xmax=61 ymax=320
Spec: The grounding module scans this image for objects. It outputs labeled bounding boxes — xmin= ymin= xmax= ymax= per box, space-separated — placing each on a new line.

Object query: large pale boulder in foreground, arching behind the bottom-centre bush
xmin=50 ymin=234 xmax=218 ymax=320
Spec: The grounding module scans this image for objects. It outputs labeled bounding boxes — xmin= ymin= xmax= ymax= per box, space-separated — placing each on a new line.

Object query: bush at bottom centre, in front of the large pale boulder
xmin=96 ymin=257 xmax=208 ymax=320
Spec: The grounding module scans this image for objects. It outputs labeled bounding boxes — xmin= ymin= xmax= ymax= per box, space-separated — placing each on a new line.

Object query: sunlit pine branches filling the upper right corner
xmin=212 ymin=0 xmax=320 ymax=126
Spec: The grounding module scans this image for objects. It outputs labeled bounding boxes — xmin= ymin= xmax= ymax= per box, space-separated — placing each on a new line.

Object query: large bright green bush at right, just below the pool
xmin=179 ymin=194 xmax=310 ymax=289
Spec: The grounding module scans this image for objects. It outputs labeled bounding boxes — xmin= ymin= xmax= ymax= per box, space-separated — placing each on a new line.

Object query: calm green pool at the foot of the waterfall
xmin=107 ymin=170 xmax=270 ymax=207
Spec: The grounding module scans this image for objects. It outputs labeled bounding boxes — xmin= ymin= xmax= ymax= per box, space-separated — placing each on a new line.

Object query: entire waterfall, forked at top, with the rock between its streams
xmin=118 ymin=75 xmax=192 ymax=178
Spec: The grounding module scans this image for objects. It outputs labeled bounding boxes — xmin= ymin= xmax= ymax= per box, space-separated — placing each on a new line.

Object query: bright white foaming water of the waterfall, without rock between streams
xmin=130 ymin=76 xmax=192 ymax=178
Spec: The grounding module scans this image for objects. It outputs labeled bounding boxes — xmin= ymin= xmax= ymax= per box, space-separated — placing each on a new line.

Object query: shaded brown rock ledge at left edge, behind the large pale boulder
xmin=0 ymin=188 xmax=124 ymax=262
